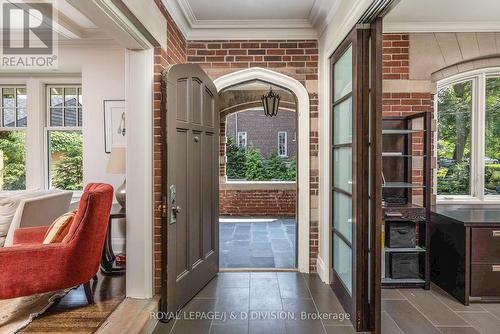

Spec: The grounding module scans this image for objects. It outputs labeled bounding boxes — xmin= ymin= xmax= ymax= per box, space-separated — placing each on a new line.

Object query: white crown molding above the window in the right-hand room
xmin=384 ymin=21 xmax=500 ymax=33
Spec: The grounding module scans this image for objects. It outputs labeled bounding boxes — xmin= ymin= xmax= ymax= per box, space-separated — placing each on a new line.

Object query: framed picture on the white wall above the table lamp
xmin=104 ymin=100 xmax=127 ymax=153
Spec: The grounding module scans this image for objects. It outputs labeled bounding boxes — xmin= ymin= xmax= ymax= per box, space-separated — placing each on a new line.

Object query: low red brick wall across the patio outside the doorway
xmin=219 ymin=190 xmax=297 ymax=217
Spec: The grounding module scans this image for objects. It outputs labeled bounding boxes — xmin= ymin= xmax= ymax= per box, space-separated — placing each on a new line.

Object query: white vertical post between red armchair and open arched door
xmin=125 ymin=49 xmax=154 ymax=298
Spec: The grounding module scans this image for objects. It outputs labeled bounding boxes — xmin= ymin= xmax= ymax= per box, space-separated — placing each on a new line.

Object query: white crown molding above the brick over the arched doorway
xmin=162 ymin=0 xmax=323 ymax=40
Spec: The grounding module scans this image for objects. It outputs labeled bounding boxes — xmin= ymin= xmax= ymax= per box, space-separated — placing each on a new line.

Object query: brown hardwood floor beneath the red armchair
xmin=21 ymin=274 xmax=125 ymax=333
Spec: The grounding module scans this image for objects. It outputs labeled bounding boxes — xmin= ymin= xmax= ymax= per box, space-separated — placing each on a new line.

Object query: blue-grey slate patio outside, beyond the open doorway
xmin=219 ymin=218 xmax=296 ymax=269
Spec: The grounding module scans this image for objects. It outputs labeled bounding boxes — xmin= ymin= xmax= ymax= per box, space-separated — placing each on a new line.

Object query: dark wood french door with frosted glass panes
xmin=330 ymin=19 xmax=382 ymax=332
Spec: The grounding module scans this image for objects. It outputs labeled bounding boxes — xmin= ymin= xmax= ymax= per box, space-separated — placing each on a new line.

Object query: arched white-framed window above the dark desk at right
xmin=435 ymin=69 xmax=500 ymax=201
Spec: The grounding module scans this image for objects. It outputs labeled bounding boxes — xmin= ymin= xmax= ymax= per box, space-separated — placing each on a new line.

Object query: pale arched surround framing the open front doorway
xmin=214 ymin=67 xmax=310 ymax=273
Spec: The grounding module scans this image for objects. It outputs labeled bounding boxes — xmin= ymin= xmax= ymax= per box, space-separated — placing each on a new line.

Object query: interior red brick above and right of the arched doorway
xmin=187 ymin=40 xmax=319 ymax=272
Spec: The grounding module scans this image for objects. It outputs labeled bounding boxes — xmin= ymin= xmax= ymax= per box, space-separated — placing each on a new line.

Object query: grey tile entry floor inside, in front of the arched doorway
xmin=154 ymin=272 xmax=355 ymax=334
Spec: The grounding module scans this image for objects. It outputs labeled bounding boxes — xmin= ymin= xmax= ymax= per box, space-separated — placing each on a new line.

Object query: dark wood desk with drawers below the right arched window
xmin=430 ymin=205 xmax=500 ymax=305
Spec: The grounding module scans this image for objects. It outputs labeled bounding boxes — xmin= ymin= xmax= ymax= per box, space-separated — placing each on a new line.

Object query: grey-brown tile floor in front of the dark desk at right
xmin=382 ymin=285 xmax=500 ymax=334
